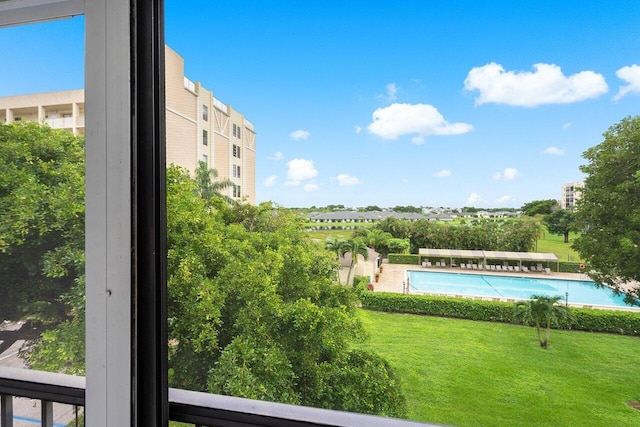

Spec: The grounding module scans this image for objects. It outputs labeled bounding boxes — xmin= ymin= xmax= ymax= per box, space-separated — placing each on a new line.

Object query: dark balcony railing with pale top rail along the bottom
xmin=0 ymin=366 xmax=433 ymax=427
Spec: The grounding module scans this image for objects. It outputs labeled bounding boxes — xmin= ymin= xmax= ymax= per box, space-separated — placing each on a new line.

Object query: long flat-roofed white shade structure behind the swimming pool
xmin=418 ymin=248 xmax=560 ymax=271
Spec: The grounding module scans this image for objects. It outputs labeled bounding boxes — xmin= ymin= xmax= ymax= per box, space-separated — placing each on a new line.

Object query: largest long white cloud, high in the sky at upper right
xmin=464 ymin=62 xmax=608 ymax=107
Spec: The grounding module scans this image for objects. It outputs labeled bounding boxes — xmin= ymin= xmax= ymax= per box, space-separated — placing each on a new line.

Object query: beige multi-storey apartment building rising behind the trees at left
xmin=0 ymin=47 xmax=256 ymax=204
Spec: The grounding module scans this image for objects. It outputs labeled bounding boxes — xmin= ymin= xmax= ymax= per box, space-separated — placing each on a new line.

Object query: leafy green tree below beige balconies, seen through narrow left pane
xmin=0 ymin=122 xmax=84 ymax=322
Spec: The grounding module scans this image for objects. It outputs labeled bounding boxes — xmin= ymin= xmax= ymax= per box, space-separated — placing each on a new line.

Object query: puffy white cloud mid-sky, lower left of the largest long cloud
xmin=367 ymin=104 xmax=473 ymax=144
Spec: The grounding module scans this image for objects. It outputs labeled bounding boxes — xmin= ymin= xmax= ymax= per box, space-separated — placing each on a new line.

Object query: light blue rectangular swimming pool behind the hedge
xmin=407 ymin=270 xmax=630 ymax=308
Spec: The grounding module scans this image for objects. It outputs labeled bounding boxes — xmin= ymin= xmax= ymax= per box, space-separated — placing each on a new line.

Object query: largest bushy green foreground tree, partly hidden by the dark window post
xmin=26 ymin=159 xmax=406 ymax=417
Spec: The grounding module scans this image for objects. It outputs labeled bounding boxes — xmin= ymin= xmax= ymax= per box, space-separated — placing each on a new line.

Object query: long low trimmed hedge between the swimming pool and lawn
xmin=360 ymin=292 xmax=640 ymax=336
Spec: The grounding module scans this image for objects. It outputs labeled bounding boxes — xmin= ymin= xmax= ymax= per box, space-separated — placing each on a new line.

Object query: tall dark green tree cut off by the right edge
xmin=573 ymin=116 xmax=640 ymax=304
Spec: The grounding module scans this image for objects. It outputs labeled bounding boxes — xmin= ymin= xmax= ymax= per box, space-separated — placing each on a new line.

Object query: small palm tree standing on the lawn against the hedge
xmin=515 ymin=295 xmax=570 ymax=349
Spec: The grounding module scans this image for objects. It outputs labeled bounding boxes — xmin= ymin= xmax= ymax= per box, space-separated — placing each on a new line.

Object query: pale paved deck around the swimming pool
xmin=373 ymin=260 xmax=640 ymax=311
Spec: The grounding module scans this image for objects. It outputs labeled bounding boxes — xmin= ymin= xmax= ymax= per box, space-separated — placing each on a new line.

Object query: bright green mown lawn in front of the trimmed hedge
xmin=359 ymin=310 xmax=640 ymax=427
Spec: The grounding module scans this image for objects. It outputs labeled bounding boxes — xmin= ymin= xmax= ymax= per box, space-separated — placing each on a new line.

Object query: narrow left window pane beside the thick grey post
xmin=0 ymin=17 xmax=85 ymax=425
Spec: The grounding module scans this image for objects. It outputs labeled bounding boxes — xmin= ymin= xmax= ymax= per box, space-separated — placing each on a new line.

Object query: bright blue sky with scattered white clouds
xmin=0 ymin=0 xmax=640 ymax=208
